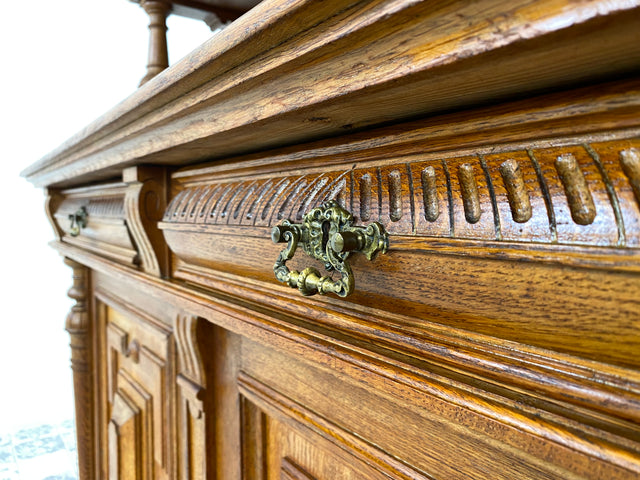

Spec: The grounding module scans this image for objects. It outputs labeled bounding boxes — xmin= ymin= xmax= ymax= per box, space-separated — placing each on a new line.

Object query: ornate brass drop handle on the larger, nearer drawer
xmin=271 ymin=200 xmax=389 ymax=297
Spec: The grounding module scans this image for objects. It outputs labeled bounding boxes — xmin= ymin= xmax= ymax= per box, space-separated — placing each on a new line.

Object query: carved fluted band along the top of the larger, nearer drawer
xmin=163 ymin=139 xmax=640 ymax=247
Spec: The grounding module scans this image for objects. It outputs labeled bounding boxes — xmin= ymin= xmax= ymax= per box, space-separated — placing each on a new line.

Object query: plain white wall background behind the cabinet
xmin=0 ymin=0 xmax=211 ymax=433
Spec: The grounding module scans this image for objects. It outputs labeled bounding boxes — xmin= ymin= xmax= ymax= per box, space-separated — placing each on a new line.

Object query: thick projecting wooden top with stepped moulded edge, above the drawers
xmin=23 ymin=0 xmax=640 ymax=187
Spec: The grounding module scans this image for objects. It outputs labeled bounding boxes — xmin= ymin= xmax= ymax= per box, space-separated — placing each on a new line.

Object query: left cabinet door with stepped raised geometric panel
xmin=101 ymin=300 xmax=176 ymax=480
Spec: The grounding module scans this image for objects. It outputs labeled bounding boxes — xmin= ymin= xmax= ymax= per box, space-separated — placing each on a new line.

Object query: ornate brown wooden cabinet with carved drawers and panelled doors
xmin=24 ymin=0 xmax=640 ymax=480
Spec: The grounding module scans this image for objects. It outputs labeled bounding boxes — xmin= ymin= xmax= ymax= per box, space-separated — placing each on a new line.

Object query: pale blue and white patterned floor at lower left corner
xmin=0 ymin=420 xmax=78 ymax=480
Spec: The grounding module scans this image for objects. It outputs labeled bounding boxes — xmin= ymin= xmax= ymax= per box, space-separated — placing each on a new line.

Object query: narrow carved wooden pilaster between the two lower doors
xmin=174 ymin=315 xmax=206 ymax=480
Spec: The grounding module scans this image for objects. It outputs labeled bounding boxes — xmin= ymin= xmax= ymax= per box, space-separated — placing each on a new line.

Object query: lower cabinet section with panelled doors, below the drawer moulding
xmin=80 ymin=273 xmax=640 ymax=480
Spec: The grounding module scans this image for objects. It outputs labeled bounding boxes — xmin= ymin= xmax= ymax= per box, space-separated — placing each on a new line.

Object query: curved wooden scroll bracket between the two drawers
xmin=123 ymin=167 xmax=169 ymax=277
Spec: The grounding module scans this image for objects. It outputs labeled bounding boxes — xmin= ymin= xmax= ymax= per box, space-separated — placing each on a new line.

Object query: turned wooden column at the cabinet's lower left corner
xmin=64 ymin=258 xmax=95 ymax=480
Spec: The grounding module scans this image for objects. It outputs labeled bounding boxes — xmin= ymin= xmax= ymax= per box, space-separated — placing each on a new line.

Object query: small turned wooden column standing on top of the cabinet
xmin=140 ymin=0 xmax=171 ymax=85
